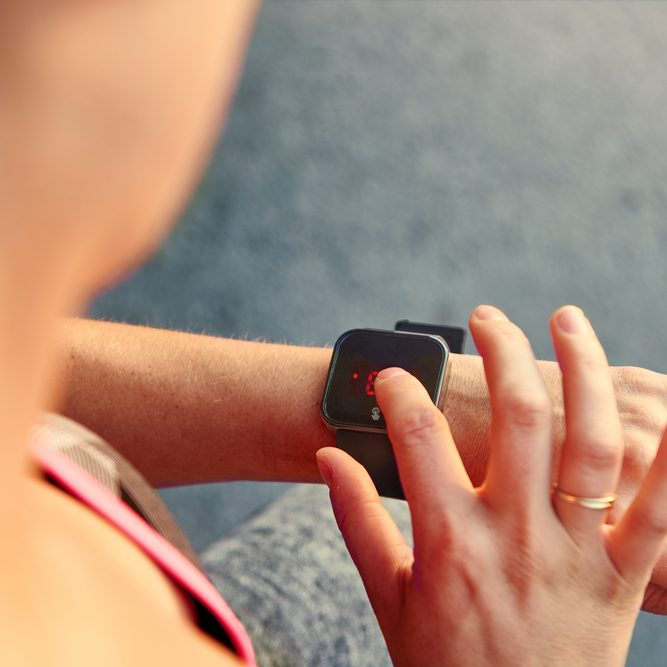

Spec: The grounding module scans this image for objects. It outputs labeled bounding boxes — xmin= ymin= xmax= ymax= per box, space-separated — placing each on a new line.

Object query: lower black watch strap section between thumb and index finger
xmin=336 ymin=428 xmax=405 ymax=499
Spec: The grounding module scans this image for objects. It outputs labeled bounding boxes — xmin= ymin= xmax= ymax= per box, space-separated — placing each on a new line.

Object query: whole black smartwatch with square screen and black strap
xmin=321 ymin=320 xmax=466 ymax=498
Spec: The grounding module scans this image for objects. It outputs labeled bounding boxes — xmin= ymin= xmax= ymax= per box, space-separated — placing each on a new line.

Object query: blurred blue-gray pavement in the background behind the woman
xmin=91 ymin=0 xmax=667 ymax=667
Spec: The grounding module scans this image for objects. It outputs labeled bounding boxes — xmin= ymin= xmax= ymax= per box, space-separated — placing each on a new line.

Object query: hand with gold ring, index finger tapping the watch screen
xmin=318 ymin=306 xmax=667 ymax=667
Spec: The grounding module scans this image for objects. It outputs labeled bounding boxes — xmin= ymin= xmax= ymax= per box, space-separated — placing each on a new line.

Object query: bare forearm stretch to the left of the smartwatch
xmin=58 ymin=319 xmax=340 ymax=486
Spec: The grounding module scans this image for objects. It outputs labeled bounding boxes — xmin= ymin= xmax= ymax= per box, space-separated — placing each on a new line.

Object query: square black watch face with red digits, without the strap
xmin=322 ymin=329 xmax=449 ymax=430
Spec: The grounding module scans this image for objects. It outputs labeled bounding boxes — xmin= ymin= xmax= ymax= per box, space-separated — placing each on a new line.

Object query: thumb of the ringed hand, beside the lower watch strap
xmin=317 ymin=447 xmax=413 ymax=630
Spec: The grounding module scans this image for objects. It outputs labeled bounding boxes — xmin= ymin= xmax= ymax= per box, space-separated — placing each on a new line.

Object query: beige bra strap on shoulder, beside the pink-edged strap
xmin=33 ymin=413 xmax=205 ymax=572
